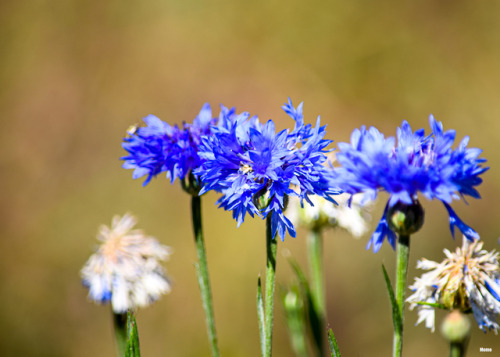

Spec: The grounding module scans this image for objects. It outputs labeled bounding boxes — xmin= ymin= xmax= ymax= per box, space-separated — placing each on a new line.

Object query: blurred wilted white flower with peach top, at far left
xmin=81 ymin=214 xmax=171 ymax=313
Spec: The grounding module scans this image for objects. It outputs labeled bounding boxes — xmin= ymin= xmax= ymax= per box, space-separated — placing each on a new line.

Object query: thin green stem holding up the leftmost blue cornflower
xmin=191 ymin=195 xmax=220 ymax=357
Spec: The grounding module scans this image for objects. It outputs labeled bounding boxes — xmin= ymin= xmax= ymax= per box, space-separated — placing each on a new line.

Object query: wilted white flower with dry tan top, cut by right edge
xmin=407 ymin=237 xmax=500 ymax=334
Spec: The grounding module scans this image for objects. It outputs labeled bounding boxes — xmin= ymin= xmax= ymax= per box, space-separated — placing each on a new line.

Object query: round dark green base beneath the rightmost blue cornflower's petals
xmin=387 ymin=200 xmax=425 ymax=236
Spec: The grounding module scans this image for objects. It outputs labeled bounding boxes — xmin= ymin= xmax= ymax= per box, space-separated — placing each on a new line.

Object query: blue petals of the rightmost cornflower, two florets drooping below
xmin=336 ymin=115 xmax=488 ymax=252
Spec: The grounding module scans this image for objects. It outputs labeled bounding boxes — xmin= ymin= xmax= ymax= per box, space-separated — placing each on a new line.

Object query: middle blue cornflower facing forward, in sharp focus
xmin=195 ymin=100 xmax=339 ymax=240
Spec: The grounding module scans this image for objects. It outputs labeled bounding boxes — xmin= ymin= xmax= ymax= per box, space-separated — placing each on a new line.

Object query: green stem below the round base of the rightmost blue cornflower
xmin=392 ymin=235 xmax=410 ymax=357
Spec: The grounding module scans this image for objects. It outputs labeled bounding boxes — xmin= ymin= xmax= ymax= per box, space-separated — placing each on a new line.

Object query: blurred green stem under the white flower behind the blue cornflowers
xmin=307 ymin=229 xmax=326 ymax=356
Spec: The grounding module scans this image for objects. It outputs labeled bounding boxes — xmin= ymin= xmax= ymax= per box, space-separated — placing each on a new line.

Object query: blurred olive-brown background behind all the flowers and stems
xmin=0 ymin=0 xmax=500 ymax=357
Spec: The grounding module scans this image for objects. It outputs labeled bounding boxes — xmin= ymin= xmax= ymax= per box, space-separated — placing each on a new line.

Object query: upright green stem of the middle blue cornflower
xmin=264 ymin=214 xmax=278 ymax=357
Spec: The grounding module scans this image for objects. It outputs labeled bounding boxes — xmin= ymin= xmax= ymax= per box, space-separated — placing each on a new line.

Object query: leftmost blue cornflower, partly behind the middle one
xmin=121 ymin=103 xmax=216 ymax=186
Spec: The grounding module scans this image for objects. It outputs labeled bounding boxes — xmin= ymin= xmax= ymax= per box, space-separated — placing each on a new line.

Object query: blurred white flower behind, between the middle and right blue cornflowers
xmin=287 ymin=194 xmax=370 ymax=237
